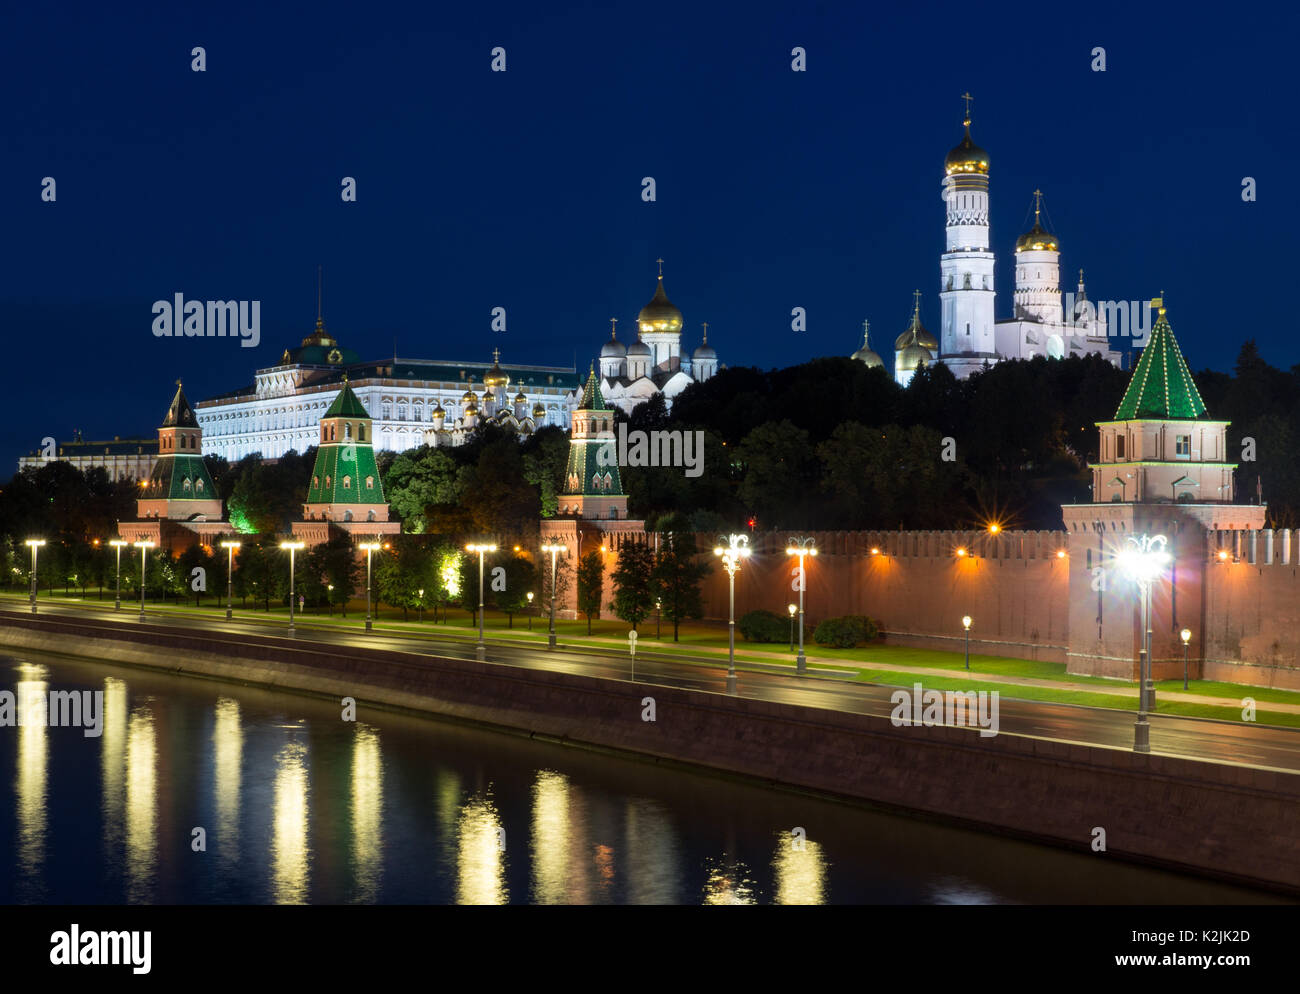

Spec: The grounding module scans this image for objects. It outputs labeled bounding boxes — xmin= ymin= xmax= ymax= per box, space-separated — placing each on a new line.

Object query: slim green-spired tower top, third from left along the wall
xmin=559 ymin=365 xmax=628 ymax=520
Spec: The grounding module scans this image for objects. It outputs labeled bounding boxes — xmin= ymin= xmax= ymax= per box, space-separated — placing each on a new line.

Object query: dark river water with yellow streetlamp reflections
xmin=0 ymin=655 xmax=1273 ymax=904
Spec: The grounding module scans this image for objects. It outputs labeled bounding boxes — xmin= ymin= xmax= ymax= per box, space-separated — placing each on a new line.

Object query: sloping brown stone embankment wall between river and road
xmin=0 ymin=612 xmax=1300 ymax=895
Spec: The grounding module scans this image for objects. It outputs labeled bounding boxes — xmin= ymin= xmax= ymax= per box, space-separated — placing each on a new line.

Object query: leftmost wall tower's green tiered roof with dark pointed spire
xmin=137 ymin=379 xmax=221 ymax=521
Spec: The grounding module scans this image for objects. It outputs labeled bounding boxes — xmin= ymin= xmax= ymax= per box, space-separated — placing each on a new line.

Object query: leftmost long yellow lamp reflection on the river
xmin=14 ymin=663 xmax=49 ymax=900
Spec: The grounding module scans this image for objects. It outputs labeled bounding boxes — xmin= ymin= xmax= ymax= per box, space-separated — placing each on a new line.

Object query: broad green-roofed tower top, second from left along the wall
xmin=295 ymin=376 xmax=397 ymax=531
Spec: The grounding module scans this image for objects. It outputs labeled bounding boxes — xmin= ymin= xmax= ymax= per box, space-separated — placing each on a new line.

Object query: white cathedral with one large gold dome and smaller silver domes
xmin=601 ymin=259 xmax=718 ymax=414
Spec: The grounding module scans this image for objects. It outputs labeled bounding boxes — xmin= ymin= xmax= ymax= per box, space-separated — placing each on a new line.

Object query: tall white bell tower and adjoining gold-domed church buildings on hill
xmin=853 ymin=94 xmax=1122 ymax=386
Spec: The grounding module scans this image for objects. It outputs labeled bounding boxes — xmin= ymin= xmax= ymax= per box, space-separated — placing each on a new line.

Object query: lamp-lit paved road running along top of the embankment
xmin=0 ymin=592 xmax=1300 ymax=772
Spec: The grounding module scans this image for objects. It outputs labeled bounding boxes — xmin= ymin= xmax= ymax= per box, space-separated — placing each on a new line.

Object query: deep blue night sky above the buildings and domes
xmin=0 ymin=1 xmax=1300 ymax=474
